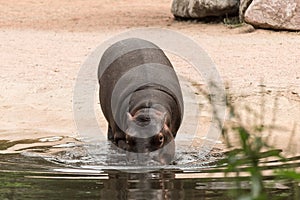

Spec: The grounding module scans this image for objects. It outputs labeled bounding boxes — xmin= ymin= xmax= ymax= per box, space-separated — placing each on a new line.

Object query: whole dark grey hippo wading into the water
xmin=98 ymin=38 xmax=183 ymax=152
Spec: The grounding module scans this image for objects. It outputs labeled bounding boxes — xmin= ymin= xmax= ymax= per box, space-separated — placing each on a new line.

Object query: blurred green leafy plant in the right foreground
xmin=206 ymin=83 xmax=300 ymax=200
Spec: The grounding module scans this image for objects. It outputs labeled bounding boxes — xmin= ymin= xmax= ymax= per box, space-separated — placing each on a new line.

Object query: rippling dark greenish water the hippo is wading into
xmin=0 ymin=138 xmax=300 ymax=199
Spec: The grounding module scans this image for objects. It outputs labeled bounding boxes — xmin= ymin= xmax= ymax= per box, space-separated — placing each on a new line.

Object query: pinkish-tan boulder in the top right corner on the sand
xmin=244 ymin=0 xmax=300 ymax=31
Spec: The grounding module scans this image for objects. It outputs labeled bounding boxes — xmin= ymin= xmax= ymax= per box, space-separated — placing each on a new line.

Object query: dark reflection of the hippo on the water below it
xmin=100 ymin=171 xmax=184 ymax=199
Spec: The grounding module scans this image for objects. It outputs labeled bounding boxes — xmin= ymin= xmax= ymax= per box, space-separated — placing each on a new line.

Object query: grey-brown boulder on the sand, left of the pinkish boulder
xmin=171 ymin=0 xmax=239 ymax=18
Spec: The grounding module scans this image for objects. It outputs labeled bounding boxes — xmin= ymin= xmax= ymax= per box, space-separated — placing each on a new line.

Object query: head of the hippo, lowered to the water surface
xmin=126 ymin=109 xmax=174 ymax=153
